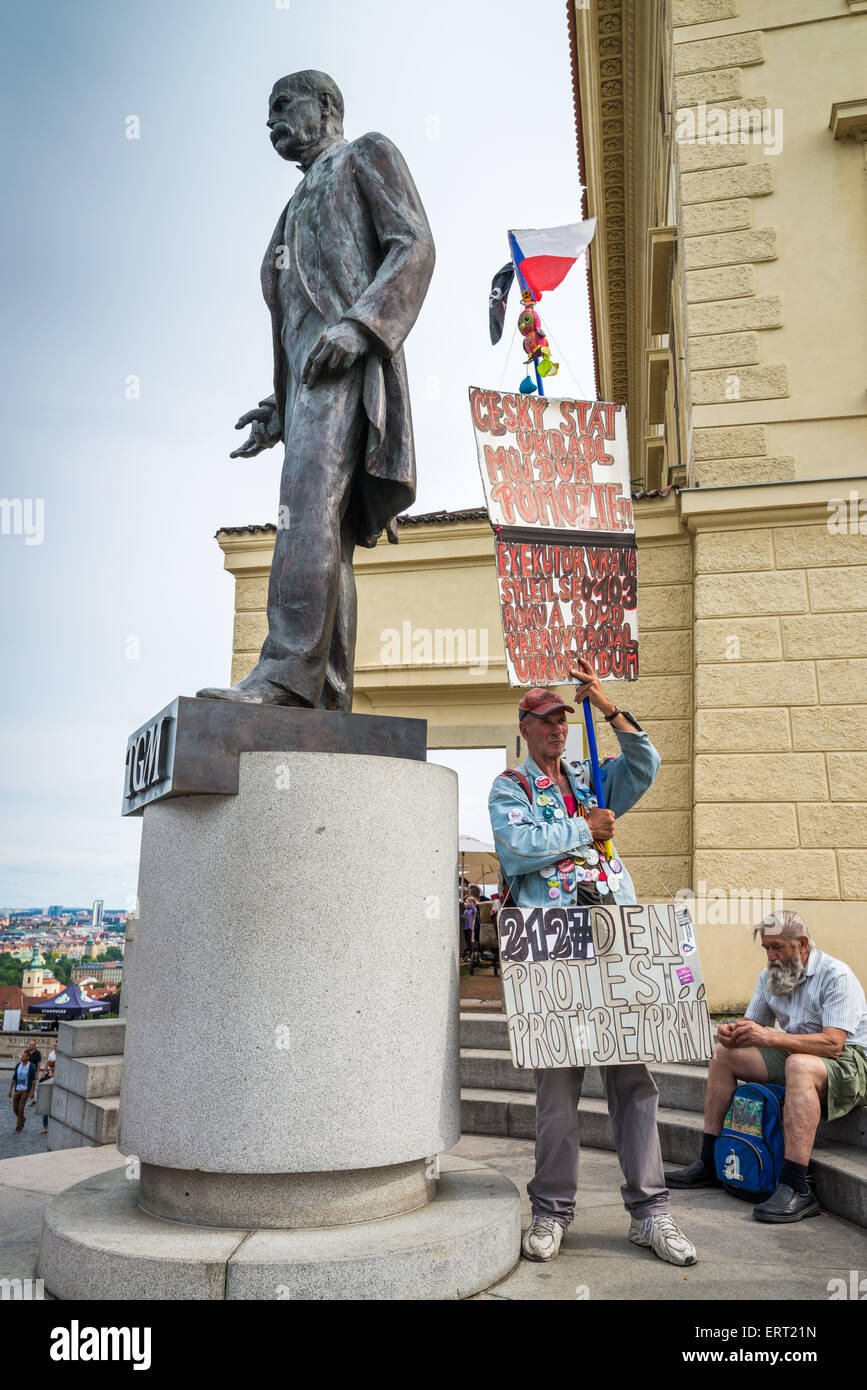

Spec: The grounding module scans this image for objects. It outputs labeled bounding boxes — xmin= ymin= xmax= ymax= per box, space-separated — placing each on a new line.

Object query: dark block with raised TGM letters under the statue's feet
xmin=122 ymin=695 xmax=428 ymax=816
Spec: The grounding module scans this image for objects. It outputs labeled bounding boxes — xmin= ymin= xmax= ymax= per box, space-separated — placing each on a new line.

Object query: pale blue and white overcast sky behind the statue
xmin=0 ymin=0 xmax=595 ymax=906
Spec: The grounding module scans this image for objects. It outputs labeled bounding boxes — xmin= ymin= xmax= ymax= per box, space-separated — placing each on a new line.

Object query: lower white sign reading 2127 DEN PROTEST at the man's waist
xmin=497 ymin=902 xmax=714 ymax=1069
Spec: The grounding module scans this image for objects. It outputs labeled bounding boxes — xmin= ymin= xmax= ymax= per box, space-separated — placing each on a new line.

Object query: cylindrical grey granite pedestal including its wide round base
xmin=40 ymin=733 xmax=520 ymax=1298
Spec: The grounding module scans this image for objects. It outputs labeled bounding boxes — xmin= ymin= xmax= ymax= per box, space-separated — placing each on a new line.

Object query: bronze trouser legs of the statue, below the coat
xmin=254 ymin=363 xmax=367 ymax=708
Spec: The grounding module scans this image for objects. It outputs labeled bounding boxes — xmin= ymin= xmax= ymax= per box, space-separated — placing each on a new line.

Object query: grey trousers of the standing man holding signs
xmin=527 ymin=1062 xmax=668 ymax=1226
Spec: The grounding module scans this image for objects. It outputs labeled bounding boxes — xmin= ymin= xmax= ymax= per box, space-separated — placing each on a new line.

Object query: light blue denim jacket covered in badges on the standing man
xmin=488 ymin=730 xmax=660 ymax=908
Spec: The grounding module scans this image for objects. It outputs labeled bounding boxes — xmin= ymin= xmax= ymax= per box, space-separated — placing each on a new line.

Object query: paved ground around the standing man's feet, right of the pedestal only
xmin=450 ymin=1134 xmax=867 ymax=1301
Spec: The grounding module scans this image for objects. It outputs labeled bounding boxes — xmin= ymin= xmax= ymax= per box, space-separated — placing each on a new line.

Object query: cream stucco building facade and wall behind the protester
xmin=211 ymin=0 xmax=867 ymax=1009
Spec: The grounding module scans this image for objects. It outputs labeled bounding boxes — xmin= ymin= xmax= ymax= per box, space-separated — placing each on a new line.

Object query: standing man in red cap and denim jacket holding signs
xmin=488 ymin=657 xmax=696 ymax=1265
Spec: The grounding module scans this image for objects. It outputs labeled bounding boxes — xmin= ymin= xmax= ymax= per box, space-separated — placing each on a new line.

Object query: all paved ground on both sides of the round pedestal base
xmin=0 ymin=1134 xmax=867 ymax=1304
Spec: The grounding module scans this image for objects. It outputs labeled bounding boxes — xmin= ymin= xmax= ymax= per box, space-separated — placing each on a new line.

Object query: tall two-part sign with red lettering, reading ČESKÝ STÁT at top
xmin=470 ymin=386 xmax=638 ymax=685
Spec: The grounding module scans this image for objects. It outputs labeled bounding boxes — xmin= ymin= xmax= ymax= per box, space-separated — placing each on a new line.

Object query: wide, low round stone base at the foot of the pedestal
xmin=39 ymin=1158 xmax=521 ymax=1301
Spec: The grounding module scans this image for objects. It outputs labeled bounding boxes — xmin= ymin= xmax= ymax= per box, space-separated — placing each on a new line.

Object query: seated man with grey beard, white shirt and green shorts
xmin=666 ymin=912 xmax=867 ymax=1223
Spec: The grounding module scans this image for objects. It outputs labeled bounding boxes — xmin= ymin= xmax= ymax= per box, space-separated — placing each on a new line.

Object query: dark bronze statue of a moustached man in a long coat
xmin=199 ymin=71 xmax=434 ymax=710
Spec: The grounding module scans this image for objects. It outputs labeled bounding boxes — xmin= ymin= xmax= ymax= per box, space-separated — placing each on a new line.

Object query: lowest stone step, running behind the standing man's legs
xmin=461 ymin=1087 xmax=867 ymax=1226
